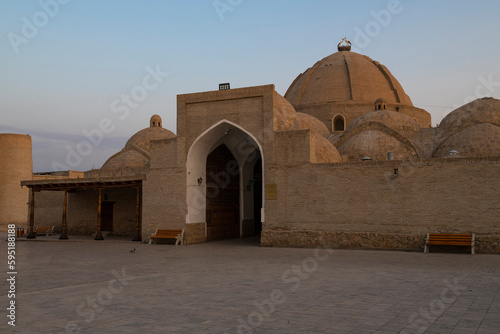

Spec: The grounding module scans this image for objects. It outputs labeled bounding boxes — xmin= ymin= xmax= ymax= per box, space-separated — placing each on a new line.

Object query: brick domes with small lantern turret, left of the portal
xmin=88 ymin=115 xmax=175 ymax=177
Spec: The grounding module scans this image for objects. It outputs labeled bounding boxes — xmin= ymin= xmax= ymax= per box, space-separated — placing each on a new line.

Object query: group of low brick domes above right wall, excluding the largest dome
xmin=329 ymin=98 xmax=500 ymax=161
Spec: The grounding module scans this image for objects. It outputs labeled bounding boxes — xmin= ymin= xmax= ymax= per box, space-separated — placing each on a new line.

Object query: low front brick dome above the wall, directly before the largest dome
xmin=338 ymin=130 xmax=412 ymax=161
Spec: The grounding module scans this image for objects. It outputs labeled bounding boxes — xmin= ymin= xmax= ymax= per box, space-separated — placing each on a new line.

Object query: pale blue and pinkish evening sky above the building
xmin=0 ymin=0 xmax=500 ymax=171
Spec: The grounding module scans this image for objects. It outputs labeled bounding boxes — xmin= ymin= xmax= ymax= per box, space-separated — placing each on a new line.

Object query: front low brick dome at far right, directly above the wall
xmin=433 ymin=123 xmax=500 ymax=158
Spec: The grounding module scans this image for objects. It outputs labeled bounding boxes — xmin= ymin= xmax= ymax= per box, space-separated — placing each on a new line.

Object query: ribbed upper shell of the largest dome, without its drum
xmin=285 ymin=51 xmax=413 ymax=107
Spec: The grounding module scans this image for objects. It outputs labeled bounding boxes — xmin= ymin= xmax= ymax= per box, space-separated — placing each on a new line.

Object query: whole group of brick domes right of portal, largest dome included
xmin=285 ymin=39 xmax=500 ymax=161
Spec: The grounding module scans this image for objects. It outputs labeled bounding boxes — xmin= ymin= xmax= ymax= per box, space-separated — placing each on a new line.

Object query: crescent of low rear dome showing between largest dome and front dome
xmin=346 ymin=110 xmax=421 ymax=139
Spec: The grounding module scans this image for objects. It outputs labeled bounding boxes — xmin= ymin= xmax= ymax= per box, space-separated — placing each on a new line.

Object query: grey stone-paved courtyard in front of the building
xmin=0 ymin=236 xmax=500 ymax=334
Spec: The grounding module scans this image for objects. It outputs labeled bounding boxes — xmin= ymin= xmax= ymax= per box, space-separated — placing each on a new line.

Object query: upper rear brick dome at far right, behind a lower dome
xmin=439 ymin=98 xmax=500 ymax=138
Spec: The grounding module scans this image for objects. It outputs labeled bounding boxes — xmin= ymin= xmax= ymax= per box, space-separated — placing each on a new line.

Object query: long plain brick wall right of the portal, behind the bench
xmin=261 ymin=157 xmax=500 ymax=253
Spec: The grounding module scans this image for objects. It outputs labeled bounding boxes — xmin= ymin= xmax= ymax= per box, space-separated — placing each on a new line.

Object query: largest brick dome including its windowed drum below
xmin=285 ymin=47 xmax=431 ymax=134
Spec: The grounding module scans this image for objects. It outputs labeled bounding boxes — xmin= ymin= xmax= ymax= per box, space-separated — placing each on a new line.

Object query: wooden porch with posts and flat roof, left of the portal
xmin=21 ymin=176 xmax=144 ymax=241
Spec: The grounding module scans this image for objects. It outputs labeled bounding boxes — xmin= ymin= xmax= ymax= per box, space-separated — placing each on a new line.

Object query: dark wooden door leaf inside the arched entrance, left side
xmin=206 ymin=145 xmax=240 ymax=240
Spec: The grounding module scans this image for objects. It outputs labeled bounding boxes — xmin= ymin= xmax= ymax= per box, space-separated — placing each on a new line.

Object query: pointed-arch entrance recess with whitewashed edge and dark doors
xmin=186 ymin=120 xmax=264 ymax=240
